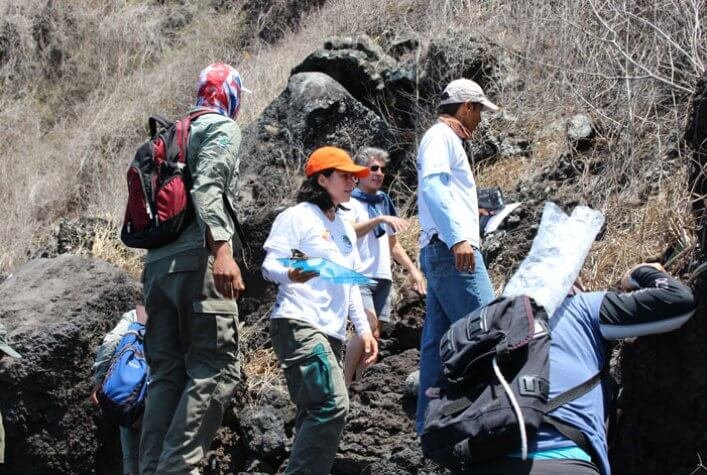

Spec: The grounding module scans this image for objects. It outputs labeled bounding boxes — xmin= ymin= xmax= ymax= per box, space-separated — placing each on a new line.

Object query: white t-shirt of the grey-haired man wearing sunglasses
xmin=339 ymin=198 xmax=395 ymax=280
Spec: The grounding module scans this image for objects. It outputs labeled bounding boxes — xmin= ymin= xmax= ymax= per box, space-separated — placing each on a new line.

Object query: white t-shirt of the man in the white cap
xmin=417 ymin=123 xmax=481 ymax=248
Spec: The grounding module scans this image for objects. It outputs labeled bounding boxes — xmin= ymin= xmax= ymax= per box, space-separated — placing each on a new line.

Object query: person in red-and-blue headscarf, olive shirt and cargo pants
xmin=140 ymin=63 xmax=245 ymax=475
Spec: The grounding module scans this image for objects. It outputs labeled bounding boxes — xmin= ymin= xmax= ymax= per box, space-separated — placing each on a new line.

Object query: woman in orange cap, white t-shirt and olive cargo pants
xmin=262 ymin=147 xmax=378 ymax=475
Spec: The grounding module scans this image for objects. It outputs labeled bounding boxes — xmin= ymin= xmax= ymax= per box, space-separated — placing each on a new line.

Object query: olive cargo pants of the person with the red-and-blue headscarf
xmin=140 ymin=249 xmax=240 ymax=475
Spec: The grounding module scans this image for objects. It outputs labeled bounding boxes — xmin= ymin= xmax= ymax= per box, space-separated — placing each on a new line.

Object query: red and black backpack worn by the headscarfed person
xmin=120 ymin=110 xmax=212 ymax=249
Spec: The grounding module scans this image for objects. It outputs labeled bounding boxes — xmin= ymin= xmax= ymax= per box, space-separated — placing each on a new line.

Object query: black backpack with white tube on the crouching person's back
xmin=421 ymin=296 xmax=602 ymax=472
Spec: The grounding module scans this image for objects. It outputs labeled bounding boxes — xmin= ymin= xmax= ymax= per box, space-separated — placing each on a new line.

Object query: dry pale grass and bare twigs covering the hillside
xmin=0 ymin=0 xmax=707 ymax=285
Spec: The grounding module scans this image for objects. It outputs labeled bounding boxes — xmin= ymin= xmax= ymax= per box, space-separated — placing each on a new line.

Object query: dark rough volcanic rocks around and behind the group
xmin=0 ymin=28 xmax=707 ymax=475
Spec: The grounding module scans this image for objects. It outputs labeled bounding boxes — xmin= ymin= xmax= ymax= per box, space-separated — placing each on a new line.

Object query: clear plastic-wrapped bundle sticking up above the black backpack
xmin=503 ymin=202 xmax=604 ymax=315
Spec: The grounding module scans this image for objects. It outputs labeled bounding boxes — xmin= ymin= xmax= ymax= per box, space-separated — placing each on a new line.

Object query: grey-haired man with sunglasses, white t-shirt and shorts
xmin=343 ymin=147 xmax=426 ymax=385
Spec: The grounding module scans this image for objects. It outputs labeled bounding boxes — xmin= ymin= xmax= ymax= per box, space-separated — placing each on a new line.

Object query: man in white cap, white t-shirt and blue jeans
xmin=416 ymin=79 xmax=498 ymax=433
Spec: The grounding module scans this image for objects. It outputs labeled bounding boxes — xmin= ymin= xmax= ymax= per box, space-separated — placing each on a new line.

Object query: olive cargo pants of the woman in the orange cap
xmin=270 ymin=318 xmax=349 ymax=475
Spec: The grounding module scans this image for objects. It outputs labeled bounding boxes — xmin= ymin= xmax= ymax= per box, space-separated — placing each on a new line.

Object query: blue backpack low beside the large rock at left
xmin=97 ymin=322 xmax=149 ymax=427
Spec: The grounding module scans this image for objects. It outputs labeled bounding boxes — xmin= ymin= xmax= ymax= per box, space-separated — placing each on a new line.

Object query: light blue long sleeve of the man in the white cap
xmin=422 ymin=173 xmax=470 ymax=249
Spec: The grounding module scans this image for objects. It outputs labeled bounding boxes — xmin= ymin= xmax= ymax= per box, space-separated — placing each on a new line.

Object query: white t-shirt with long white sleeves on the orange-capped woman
xmin=263 ymin=202 xmax=370 ymax=340
